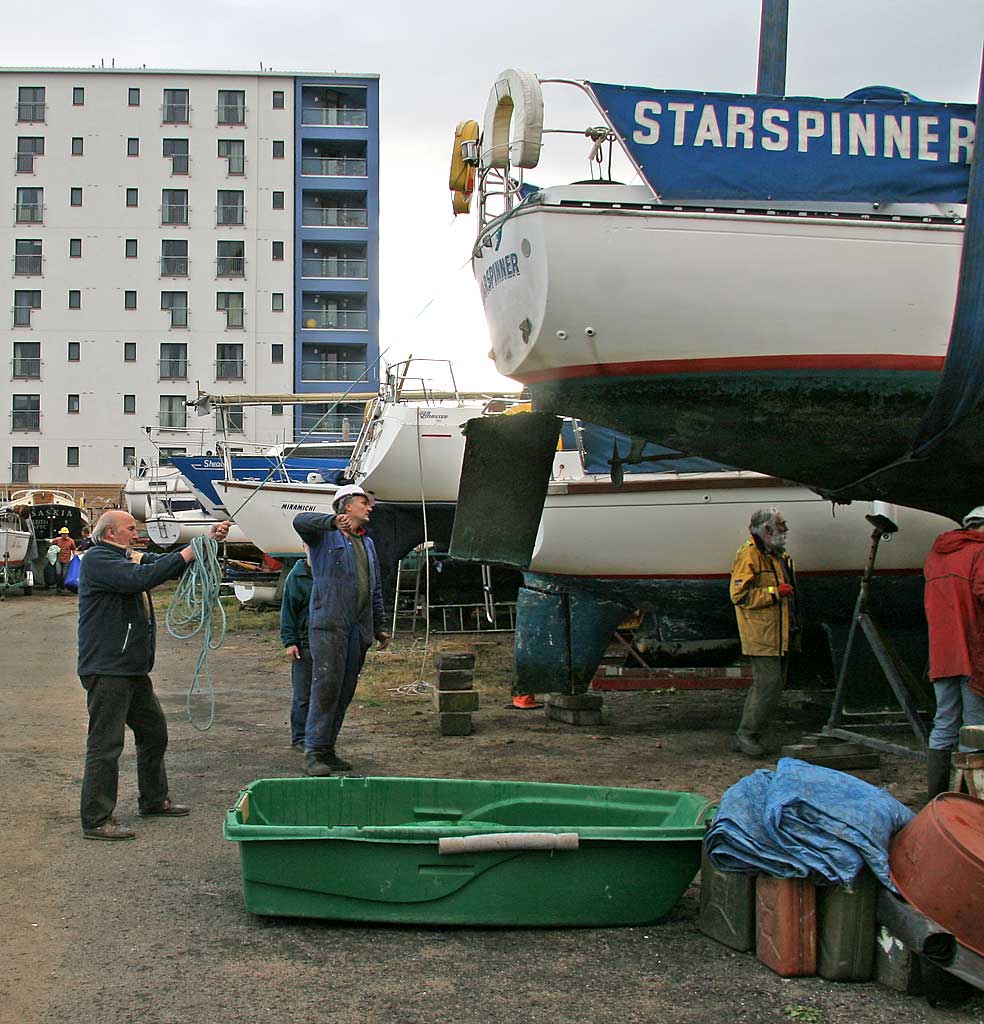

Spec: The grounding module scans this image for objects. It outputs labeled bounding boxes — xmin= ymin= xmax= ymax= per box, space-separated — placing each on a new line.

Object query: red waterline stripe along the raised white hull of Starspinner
xmin=517 ymin=352 xmax=943 ymax=384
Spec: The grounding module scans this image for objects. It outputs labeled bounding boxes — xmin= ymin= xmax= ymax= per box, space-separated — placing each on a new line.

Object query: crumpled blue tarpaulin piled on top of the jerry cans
xmin=705 ymin=758 xmax=913 ymax=891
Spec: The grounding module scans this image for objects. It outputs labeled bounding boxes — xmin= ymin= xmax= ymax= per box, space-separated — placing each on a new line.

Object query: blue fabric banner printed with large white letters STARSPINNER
xmin=586 ymin=82 xmax=977 ymax=204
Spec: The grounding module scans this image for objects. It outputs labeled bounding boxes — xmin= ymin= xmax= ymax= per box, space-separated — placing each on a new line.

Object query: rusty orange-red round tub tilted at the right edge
xmin=889 ymin=793 xmax=984 ymax=956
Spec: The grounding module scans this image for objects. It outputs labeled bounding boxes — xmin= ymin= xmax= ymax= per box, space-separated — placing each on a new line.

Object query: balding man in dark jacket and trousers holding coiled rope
xmin=78 ymin=510 xmax=230 ymax=840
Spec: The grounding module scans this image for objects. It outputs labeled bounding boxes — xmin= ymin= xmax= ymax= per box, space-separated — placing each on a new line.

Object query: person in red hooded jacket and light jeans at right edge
xmin=923 ymin=505 xmax=984 ymax=800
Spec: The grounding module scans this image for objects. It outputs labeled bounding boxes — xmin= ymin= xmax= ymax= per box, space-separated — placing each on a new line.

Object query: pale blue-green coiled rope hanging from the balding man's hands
xmin=165 ymin=537 xmax=225 ymax=732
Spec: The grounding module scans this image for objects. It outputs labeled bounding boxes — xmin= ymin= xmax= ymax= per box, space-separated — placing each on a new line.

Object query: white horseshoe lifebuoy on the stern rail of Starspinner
xmin=481 ymin=68 xmax=544 ymax=167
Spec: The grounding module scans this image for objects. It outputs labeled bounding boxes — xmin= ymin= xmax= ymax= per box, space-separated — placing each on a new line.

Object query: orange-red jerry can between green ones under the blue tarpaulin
xmin=755 ymin=874 xmax=816 ymax=978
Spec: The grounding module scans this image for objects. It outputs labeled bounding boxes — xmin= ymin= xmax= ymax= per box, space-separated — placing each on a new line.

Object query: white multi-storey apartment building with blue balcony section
xmin=0 ymin=69 xmax=378 ymax=490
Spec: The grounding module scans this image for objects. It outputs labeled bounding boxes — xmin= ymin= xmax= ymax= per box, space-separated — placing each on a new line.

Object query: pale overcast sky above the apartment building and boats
xmin=7 ymin=0 xmax=984 ymax=387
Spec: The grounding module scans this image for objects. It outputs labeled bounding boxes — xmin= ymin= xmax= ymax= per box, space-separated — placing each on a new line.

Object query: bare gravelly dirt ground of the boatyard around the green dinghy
xmin=0 ymin=594 xmax=982 ymax=1024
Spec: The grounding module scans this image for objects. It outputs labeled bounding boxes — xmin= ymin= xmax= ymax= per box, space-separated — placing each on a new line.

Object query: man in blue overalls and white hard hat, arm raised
xmin=294 ymin=484 xmax=390 ymax=775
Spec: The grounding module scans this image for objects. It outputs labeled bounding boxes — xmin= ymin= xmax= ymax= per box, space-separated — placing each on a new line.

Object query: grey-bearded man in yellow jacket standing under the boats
xmin=731 ymin=509 xmax=800 ymax=758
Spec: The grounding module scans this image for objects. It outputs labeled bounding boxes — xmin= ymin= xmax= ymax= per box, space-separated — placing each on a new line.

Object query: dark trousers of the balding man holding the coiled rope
xmin=81 ymin=676 xmax=168 ymax=828
